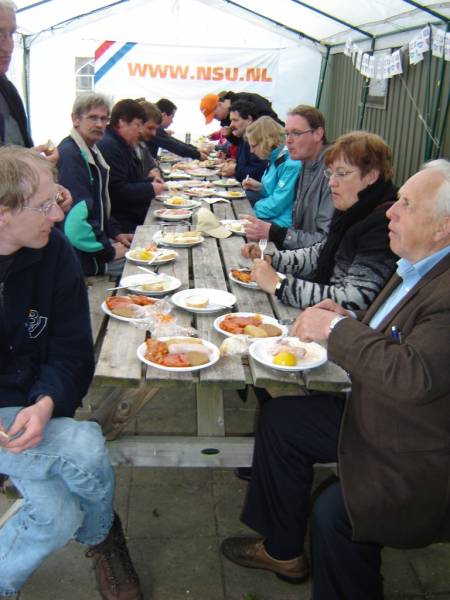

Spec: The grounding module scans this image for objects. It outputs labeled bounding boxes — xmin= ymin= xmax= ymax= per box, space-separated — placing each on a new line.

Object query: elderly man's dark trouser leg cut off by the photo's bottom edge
xmin=311 ymin=483 xmax=383 ymax=600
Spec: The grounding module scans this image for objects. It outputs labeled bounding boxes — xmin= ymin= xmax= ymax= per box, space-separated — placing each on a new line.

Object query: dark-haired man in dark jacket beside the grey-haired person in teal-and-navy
xmin=97 ymin=99 xmax=167 ymax=233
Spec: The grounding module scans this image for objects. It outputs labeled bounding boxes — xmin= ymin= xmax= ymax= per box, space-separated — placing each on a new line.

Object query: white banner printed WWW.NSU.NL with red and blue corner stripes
xmin=95 ymin=41 xmax=279 ymax=103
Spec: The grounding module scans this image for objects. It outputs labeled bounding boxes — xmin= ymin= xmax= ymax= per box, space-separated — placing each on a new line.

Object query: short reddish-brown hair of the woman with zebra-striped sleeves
xmin=325 ymin=131 xmax=394 ymax=181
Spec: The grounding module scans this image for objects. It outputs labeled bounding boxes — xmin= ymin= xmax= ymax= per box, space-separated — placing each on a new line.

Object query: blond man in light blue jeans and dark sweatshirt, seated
xmin=0 ymin=147 xmax=142 ymax=600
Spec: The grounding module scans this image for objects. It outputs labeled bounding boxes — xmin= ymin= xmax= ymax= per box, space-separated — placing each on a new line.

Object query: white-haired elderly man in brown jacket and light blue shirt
xmin=222 ymin=160 xmax=450 ymax=600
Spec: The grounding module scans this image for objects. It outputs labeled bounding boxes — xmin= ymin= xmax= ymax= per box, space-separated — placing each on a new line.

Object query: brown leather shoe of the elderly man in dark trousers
xmin=221 ymin=538 xmax=309 ymax=583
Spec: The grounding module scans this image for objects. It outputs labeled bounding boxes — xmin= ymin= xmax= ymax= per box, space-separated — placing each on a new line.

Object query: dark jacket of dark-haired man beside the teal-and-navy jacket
xmin=97 ymin=127 xmax=155 ymax=233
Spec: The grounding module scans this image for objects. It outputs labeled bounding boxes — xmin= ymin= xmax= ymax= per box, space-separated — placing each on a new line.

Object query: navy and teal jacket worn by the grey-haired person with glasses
xmin=58 ymin=130 xmax=121 ymax=275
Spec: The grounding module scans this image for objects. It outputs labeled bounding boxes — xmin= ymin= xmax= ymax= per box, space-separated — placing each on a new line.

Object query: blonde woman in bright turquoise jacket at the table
xmin=242 ymin=116 xmax=301 ymax=227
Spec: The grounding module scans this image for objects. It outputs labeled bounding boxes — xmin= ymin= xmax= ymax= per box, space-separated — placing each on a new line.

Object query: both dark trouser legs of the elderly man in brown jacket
xmin=242 ymin=395 xmax=383 ymax=600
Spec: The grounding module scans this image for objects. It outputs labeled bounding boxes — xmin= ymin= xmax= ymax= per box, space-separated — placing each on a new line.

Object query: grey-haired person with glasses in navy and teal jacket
xmin=58 ymin=93 xmax=133 ymax=276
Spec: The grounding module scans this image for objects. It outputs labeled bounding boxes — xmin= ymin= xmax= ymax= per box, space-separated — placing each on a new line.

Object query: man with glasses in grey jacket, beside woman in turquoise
xmin=243 ymin=105 xmax=334 ymax=250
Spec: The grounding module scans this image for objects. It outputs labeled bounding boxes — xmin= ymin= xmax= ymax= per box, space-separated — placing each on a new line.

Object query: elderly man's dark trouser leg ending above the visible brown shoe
xmin=242 ymin=396 xmax=344 ymax=560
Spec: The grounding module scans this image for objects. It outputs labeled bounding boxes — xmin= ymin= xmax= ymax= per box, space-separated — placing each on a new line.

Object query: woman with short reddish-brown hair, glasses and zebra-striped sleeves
xmin=242 ymin=131 xmax=396 ymax=310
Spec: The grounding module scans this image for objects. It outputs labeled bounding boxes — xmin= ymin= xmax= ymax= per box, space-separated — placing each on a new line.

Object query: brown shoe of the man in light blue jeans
xmin=86 ymin=515 xmax=143 ymax=600
